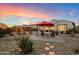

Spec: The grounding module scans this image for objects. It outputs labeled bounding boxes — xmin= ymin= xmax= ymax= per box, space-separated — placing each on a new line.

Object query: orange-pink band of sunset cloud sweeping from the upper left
xmin=0 ymin=5 xmax=49 ymax=19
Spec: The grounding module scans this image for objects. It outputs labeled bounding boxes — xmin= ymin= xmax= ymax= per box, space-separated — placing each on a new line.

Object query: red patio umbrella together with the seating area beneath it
xmin=35 ymin=21 xmax=54 ymax=37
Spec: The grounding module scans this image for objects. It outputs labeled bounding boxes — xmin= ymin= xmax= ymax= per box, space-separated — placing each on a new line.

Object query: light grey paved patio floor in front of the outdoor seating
xmin=31 ymin=35 xmax=64 ymax=42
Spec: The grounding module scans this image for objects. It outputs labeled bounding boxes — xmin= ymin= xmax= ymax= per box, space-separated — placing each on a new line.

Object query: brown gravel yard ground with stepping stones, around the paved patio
xmin=0 ymin=34 xmax=79 ymax=55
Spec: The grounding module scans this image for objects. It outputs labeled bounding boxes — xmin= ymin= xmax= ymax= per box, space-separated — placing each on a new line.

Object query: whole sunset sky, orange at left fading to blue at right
xmin=0 ymin=3 xmax=79 ymax=26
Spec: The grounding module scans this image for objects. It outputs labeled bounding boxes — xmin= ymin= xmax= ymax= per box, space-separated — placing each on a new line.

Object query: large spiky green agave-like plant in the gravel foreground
xmin=18 ymin=37 xmax=33 ymax=54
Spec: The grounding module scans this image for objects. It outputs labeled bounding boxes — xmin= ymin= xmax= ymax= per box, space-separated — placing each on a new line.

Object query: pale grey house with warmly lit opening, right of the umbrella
xmin=50 ymin=19 xmax=74 ymax=32
